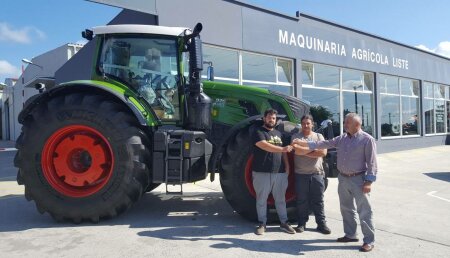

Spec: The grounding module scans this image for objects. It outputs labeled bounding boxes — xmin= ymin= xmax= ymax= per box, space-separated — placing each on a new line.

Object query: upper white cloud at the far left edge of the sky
xmin=0 ymin=22 xmax=46 ymax=44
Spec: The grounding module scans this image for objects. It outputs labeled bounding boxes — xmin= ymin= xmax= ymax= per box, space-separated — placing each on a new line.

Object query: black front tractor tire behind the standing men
xmin=219 ymin=125 xmax=297 ymax=223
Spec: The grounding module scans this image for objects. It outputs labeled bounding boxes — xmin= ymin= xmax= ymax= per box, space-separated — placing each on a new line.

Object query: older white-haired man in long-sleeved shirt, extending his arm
xmin=293 ymin=113 xmax=377 ymax=252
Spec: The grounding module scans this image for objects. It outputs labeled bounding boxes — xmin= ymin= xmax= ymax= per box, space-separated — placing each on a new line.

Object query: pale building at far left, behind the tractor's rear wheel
xmin=1 ymin=44 xmax=83 ymax=140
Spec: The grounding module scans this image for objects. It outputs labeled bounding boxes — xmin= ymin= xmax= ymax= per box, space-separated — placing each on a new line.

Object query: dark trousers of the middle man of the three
xmin=295 ymin=174 xmax=326 ymax=226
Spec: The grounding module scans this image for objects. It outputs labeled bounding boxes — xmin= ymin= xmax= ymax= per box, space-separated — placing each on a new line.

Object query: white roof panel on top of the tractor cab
xmin=93 ymin=24 xmax=188 ymax=36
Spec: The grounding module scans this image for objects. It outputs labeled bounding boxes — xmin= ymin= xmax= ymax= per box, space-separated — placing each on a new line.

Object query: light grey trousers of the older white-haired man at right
xmin=338 ymin=175 xmax=375 ymax=244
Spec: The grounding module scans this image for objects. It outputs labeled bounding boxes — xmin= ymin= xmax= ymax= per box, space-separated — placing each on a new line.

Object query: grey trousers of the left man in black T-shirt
xmin=253 ymin=171 xmax=288 ymax=225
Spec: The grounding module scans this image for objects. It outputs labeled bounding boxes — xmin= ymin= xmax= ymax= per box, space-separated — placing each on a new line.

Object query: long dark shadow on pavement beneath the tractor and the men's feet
xmin=0 ymin=189 xmax=357 ymax=255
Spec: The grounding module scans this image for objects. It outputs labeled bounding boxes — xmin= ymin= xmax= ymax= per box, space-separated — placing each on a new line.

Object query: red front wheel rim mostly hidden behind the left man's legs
xmin=245 ymin=154 xmax=295 ymax=205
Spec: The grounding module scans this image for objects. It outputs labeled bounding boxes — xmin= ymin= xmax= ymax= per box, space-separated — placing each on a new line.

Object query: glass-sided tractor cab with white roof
xmin=93 ymin=25 xmax=187 ymax=121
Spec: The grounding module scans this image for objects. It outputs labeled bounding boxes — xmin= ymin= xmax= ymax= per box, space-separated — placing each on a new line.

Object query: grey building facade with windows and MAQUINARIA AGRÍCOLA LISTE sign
xmin=149 ymin=0 xmax=450 ymax=152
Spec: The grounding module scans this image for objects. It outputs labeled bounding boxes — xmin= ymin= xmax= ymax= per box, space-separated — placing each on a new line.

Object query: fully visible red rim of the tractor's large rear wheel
xmin=41 ymin=125 xmax=114 ymax=197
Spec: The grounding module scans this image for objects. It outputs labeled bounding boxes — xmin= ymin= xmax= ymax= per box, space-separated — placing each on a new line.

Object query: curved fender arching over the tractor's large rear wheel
xmin=18 ymin=82 xmax=148 ymax=126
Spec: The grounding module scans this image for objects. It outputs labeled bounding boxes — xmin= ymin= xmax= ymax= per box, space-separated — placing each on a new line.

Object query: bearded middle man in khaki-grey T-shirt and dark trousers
xmin=292 ymin=115 xmax=331 ymax=234
